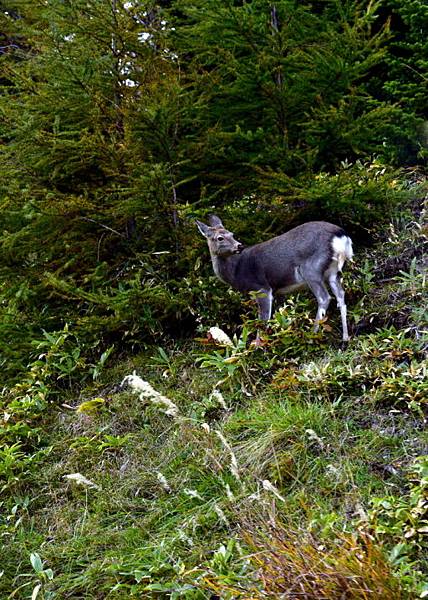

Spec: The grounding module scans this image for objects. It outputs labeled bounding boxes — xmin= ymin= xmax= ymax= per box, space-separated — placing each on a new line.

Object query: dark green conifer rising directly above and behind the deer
xmin=173 ymin=0 xmax=414 ymax=193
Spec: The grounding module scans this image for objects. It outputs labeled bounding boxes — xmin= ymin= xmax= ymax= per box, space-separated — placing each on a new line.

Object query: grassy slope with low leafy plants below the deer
xmin=0 ymin=195 xmax=428 ymax=600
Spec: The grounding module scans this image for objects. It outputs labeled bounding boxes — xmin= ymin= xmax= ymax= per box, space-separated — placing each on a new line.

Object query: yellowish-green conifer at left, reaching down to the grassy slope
xmin=0 ymin=0 xmax=187 ymax=376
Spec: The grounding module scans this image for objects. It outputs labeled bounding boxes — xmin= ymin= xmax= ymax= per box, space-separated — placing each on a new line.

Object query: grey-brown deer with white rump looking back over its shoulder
xmin=195 ymin=215 xmax=353 ymax=345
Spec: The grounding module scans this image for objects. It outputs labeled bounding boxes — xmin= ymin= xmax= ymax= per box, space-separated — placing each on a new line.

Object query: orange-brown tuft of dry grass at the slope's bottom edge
xmin=208 ymin=524 xmax=404 ymax=600
